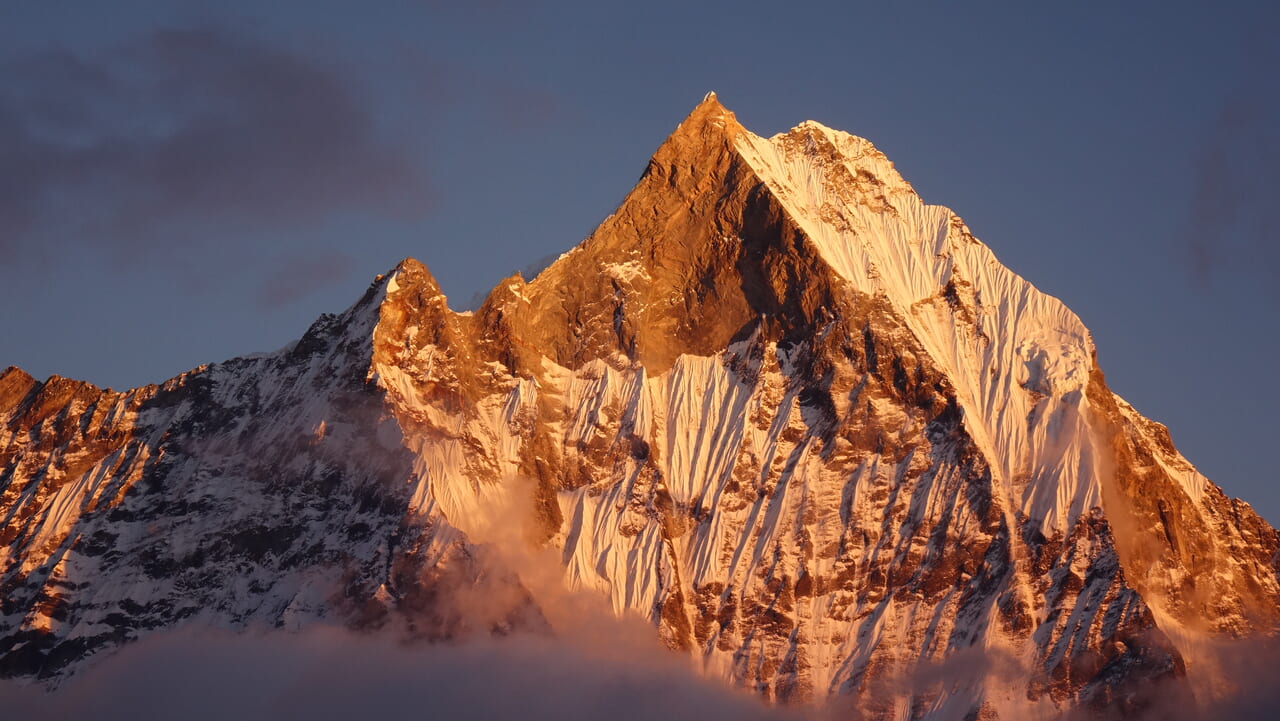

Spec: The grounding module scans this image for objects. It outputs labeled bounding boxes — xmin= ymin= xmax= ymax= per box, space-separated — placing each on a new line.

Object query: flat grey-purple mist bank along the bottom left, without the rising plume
xmin=0 ymin=628 xmax=797 ymax=721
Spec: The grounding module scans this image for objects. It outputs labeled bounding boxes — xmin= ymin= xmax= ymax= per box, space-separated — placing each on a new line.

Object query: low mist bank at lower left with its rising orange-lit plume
xmin=0 ymin=479 xmax=803 ymax=721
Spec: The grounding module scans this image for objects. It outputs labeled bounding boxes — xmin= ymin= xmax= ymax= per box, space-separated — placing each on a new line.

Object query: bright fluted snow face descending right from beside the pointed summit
xmin=736 ymin=120 xmax=1101 ymax=534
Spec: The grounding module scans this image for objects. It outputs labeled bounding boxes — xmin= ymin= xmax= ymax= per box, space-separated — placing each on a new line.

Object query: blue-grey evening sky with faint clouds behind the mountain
xmin=0 ymin=0 xmax=1280 ymax=521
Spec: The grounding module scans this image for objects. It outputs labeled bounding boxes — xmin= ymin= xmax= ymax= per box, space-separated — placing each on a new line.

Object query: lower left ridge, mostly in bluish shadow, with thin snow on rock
xmin=0 ymin=281 xmax=529 ymax=677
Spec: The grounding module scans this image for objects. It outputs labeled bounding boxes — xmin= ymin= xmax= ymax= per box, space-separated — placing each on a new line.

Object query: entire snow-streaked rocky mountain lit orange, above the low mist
xmin=0 ymin=96 xmax=1280 ymax=720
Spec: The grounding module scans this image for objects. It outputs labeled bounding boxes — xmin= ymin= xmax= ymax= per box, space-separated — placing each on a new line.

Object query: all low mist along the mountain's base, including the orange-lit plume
xmin=0 ymin=479 xmax=1280 ymax=721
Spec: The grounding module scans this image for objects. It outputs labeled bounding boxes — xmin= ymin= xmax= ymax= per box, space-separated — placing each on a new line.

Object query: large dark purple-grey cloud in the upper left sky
xmin=0 ymin=27 xmax=430 ymax=290
